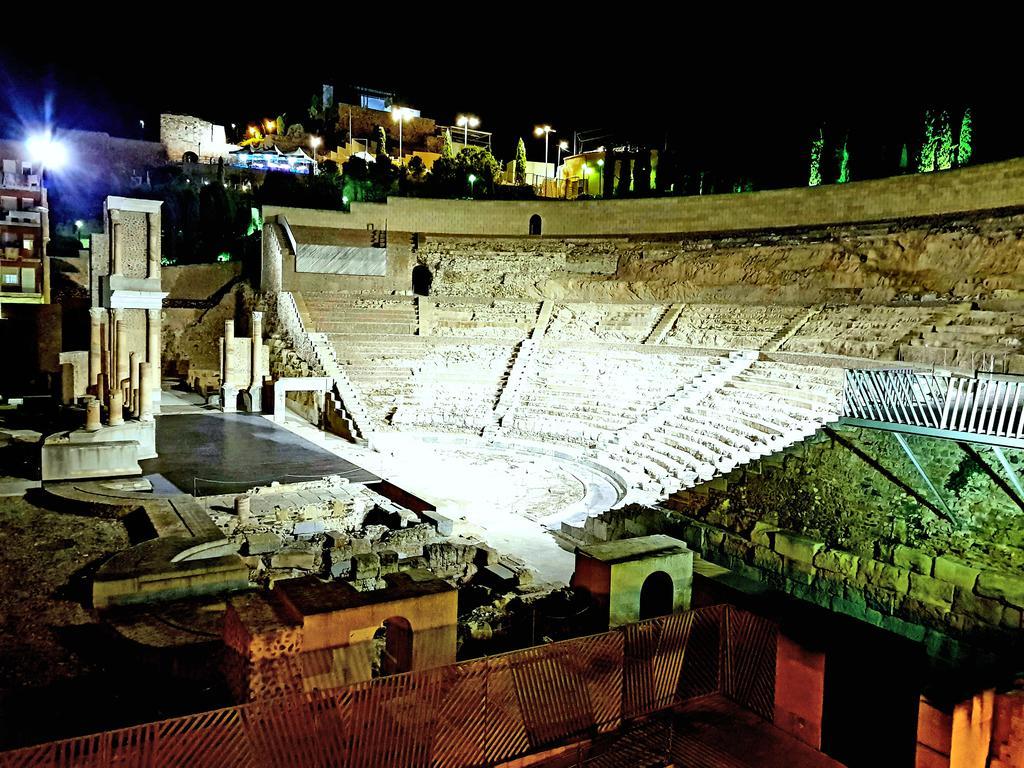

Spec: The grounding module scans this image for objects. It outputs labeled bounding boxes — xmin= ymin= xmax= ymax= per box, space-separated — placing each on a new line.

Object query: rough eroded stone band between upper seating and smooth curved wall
xmin=418 ymin=214 xmax=1024 ymax=303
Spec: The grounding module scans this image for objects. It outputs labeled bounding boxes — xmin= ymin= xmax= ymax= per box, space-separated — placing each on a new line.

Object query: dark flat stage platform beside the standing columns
xmin=140 ymin=413 xmax=380 ymax=496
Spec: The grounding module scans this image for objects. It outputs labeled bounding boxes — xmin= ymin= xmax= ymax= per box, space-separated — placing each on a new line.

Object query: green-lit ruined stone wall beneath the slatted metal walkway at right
xmin=578 ymin=428 xmax=1024 ymax=655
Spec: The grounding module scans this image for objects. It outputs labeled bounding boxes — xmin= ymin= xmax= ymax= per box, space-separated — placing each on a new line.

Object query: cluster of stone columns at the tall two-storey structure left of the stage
xmin=86 ymin=303 xmax=161 ymax=430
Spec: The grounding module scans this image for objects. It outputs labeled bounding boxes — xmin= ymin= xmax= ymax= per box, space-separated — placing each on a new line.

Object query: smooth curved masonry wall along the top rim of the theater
xmin=264 ymin=159 xmax=1024 ymax=237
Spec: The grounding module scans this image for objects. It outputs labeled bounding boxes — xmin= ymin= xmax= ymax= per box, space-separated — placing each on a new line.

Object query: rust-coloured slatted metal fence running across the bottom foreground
xmin=0 ymin=605 xmax=776 ymax=768
